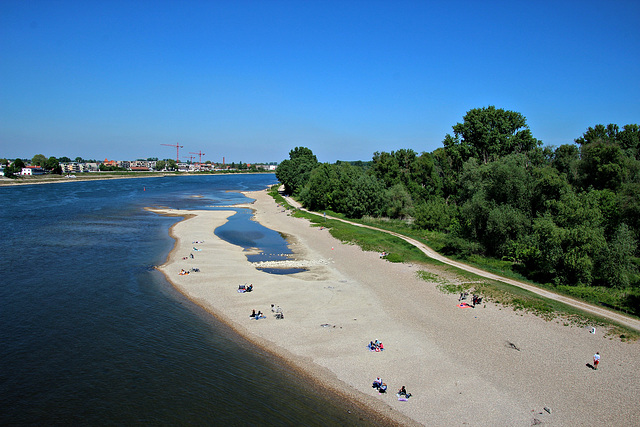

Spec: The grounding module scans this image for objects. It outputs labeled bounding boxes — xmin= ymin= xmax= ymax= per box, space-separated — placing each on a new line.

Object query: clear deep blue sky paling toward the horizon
xmin=0 ymin=0 xmax=640 ymax=163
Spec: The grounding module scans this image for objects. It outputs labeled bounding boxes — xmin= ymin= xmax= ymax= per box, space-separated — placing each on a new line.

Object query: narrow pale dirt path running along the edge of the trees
xmin=281 ymin=192 xmax=640 ymax=331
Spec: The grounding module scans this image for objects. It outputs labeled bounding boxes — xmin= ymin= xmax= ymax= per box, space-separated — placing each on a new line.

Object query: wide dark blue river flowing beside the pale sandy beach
xmin=0 ymin=174 xmax=380 ymax=425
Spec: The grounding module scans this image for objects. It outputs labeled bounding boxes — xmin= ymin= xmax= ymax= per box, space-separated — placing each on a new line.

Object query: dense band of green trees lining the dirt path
xmin=276 ymin=106 xmax=640 ymax=288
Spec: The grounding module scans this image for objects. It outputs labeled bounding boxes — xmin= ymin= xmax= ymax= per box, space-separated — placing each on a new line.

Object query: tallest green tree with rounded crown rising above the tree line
xmin=443 ymin=106 xmax=541 ymax=170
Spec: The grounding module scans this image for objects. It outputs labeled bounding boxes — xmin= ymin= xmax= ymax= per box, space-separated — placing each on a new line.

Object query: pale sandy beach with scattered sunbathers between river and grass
xmin=154 ymin=191 xmax=640 ymax=426
